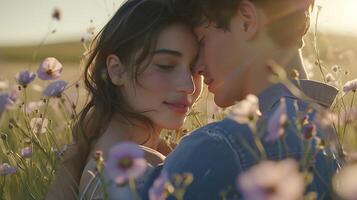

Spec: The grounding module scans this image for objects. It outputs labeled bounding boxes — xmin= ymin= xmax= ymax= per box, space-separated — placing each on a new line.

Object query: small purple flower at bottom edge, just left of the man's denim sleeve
xmin=149 ymin=171 xmax=174 ymax=200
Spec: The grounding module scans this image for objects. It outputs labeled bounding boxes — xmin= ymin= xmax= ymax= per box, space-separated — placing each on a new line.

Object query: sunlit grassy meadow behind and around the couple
xmin=0 ymin=30 xmax=357 ymax=199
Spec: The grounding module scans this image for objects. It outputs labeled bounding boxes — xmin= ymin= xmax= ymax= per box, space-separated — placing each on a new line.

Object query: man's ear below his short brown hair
xmin=237 ymin=0 xmax=260 ymax=40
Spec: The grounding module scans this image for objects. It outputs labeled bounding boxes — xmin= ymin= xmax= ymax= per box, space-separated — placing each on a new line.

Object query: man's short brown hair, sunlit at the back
xmin=174 ymin=0 xmax=315 ymax=46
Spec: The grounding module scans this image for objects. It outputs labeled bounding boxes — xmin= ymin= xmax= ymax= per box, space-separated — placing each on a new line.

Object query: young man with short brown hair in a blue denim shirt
xmin=140 ymin=0 xmax=338 ymax=199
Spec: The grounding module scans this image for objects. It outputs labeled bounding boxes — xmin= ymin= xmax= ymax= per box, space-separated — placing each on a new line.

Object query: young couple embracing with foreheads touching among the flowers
xmin=47 ymin=0 xmax=342 ymax=199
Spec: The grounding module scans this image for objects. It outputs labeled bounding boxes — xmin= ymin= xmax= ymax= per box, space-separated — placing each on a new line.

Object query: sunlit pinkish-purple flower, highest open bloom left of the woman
xmin=37 ymin=57 xmax=63 ymax=80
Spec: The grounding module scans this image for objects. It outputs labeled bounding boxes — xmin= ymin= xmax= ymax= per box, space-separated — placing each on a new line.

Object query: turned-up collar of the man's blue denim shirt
xmin=258 ymin=79 xmax=338 ymax=113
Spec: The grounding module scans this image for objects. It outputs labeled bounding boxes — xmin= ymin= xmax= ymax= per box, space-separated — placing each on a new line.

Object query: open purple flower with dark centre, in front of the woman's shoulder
xmin=105 ymin=142 xmax=147 ymax=185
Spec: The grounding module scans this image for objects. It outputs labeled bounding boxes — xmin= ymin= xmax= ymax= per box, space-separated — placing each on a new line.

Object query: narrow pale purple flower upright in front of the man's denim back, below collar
xmin=265 ymin=98 xmax=288 ymax=142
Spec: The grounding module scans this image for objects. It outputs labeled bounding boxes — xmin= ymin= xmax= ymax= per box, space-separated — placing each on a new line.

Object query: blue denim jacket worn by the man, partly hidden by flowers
xmin=142 ymin=80 xmax=340 ymax=200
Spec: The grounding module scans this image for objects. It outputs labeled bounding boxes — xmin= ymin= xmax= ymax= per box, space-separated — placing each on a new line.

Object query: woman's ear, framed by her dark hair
xmin=106 ymin=54 xmax=125 ymax=86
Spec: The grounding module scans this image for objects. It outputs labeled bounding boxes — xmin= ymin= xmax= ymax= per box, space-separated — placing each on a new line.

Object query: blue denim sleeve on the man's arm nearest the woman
xmin=163 ymin=128 xmax=240 ymax=199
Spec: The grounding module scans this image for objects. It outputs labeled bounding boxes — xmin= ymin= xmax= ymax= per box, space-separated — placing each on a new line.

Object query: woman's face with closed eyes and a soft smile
xmin=122 ymin=23 xmax=202 ymax=129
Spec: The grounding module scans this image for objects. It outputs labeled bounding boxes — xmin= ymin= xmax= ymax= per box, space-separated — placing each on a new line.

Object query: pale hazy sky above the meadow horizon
xmin=0 ymin=0 xmax=357 ymax=46
